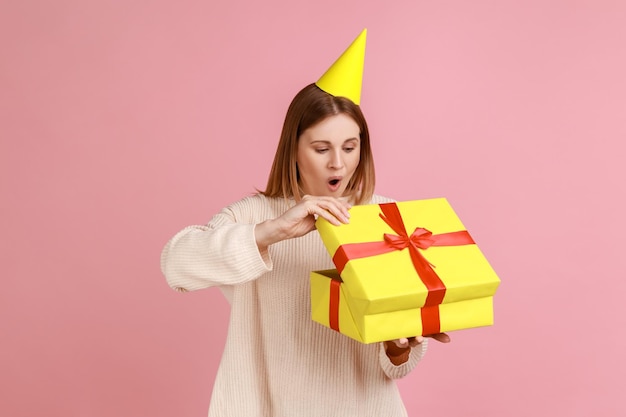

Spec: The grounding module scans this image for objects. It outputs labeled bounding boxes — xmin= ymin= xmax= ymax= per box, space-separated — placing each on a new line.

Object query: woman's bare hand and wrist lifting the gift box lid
xmin=255 ymin=195 xmax=352 ymax=250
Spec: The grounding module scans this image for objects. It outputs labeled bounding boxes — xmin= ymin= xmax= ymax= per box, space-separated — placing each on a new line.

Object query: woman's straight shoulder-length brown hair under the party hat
xmin=261 ymin=84 xmax=375 ymax=204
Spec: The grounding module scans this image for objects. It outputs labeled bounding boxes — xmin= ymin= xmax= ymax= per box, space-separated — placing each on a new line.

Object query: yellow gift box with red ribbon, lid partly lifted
xmin=311 ymin=198 xmax=500 ymax=343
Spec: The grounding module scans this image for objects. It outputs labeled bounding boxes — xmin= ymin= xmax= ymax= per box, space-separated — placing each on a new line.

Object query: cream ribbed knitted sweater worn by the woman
xmin=161 ymin=195 xmax=426 ymax=417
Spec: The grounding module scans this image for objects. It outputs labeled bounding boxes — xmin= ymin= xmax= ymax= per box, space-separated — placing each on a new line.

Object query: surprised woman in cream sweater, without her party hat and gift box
xmin=162 ymin=33 xmax=447 ymax=417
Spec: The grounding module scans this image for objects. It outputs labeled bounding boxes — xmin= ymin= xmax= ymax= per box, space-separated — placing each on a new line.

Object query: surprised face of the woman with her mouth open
xmin=296 ymin=114 xmax=361 ymax=197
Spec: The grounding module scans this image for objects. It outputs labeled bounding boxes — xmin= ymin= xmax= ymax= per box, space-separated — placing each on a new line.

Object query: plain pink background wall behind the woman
xmin=0 ymin=0 xmax=626 ymax=417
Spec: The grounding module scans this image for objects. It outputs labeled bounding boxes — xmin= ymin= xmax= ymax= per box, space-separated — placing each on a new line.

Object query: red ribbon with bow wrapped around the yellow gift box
xmin=329 ymin=203 xmax=474 ymax=335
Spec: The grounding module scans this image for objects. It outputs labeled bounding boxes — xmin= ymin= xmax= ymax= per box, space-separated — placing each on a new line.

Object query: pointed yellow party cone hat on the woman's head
xmin=315 ymin=29 xmax=367 ymax=104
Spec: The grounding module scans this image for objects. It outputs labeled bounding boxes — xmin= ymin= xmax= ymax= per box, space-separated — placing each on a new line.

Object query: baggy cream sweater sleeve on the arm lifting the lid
xmin=161 ymin=203 xmax=273 ymax=291
